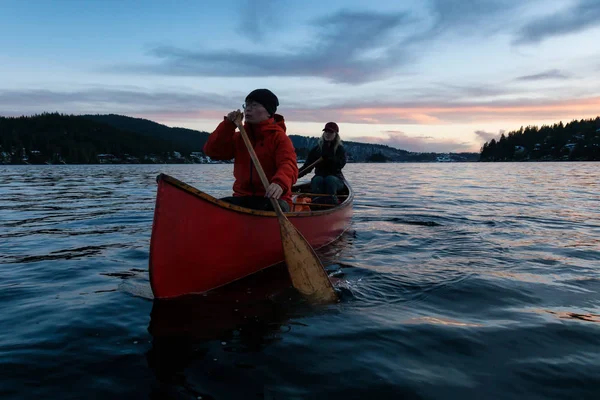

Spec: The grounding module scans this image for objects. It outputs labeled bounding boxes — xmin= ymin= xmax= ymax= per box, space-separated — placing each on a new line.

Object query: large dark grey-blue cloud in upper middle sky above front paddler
xmin=120 ymin=11 xmax=408 ymax=83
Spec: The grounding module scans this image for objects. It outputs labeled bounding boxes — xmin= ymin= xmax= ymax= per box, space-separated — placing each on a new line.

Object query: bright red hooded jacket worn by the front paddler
xmin=204 ymin=114 xmax=298 ymax=208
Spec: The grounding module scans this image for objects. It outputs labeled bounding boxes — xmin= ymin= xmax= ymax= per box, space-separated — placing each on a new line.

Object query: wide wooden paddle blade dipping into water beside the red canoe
xmin=279 ymin=216 xmax=338 ymax=303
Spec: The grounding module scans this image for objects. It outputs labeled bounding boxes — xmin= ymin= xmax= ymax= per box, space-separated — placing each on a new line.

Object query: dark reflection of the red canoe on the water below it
xmin=146 ymin=266 xmax=296 ymax=396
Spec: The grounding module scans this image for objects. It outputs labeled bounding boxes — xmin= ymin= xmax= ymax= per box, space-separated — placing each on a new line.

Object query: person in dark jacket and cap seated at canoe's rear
xmin=298 ymin=122 xmax=346 ymax=203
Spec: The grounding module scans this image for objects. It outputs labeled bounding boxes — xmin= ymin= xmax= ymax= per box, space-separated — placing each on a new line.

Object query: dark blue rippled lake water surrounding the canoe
xmin=0 ymin=163 xmax=600 ymax=399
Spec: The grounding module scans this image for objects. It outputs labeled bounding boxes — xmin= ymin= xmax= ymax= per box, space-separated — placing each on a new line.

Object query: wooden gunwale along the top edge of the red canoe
xmin=156 ymin=174 xmax=354 ymax=218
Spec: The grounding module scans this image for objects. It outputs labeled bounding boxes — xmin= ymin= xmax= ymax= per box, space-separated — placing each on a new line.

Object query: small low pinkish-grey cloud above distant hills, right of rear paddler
xmin=352 ymin=131 xmax=474 ymax=153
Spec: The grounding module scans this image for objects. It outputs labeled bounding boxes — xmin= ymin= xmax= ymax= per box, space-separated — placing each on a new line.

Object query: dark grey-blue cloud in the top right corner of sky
xmin=513 ymin=0 xmax=600 ymax=44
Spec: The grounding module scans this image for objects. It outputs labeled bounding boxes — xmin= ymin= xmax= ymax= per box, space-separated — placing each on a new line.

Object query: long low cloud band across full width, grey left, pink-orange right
xmin=0 ymin=87 xmax=600 ymax=125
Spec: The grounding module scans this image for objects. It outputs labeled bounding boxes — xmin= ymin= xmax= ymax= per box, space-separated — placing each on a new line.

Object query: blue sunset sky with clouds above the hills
xmin=0 ymin=0 xmax=600 ymax=152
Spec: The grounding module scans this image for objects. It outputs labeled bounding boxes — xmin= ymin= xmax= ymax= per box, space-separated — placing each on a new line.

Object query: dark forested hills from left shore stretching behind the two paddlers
xmin=0 ymin=113 xmax=479 ymax=164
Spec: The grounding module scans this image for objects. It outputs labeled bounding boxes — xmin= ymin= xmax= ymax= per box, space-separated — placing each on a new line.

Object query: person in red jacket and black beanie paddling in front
xmin=204 ymin=89 xmax=298 ymax=211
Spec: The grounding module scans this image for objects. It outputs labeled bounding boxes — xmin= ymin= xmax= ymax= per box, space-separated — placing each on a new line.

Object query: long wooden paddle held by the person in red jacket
xmin=235 ymin=119 xmax=338 ymax=303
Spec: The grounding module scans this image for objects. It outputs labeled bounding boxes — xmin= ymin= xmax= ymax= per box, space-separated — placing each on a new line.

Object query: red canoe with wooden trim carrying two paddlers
xmin=150 ymin=174 xmax=354 ymax=298
